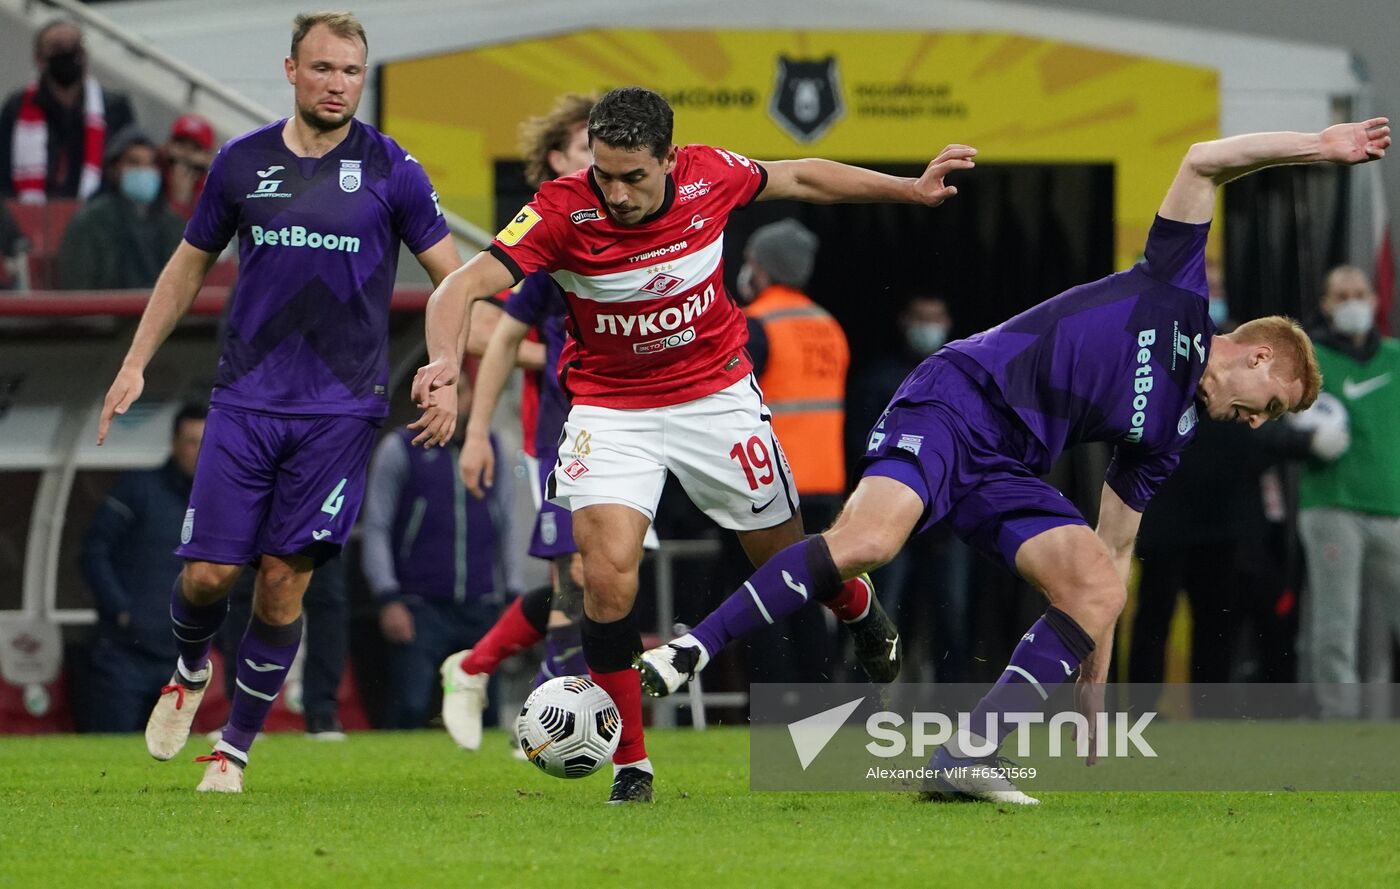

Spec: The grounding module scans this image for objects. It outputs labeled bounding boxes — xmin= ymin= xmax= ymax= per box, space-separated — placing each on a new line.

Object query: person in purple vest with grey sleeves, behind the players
xmin=360 ymin=386 xmax=505 ymax=728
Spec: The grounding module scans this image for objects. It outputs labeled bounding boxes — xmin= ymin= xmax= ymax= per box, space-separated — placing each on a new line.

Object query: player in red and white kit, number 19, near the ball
xmin=413 ymin=87 xmax=976 ymax=802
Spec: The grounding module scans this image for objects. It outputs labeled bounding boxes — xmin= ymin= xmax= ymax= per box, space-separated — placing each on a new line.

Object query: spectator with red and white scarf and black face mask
xmin=0 ymin=20 xmax=136 ymax=203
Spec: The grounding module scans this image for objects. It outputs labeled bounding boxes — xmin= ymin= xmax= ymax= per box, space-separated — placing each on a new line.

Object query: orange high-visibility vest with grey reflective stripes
xmin=743 ymin=284 xmax=851 ymax=494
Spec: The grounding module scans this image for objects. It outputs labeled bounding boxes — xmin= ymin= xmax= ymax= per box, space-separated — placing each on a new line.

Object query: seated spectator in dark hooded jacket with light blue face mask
xmin=59 ymin=129 xmax=185 ymax=290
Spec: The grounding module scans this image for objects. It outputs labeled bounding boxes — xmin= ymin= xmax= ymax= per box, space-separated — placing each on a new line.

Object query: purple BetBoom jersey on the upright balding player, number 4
xmin=185 ymin=120 xmax=448 ymax=419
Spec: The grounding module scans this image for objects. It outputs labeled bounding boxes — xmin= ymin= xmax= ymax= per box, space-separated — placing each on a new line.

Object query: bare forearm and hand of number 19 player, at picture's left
xmin=409 ymin=252 xmax=515 ymax=447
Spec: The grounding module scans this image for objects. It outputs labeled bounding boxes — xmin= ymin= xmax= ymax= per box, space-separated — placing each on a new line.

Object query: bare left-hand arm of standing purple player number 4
xmin=97 ymin=241 xmax=218 ymax=445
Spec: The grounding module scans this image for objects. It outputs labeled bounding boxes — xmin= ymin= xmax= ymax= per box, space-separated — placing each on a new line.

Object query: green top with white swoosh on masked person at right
xmin=1298 ymin=329 xmax=1400 ymax=515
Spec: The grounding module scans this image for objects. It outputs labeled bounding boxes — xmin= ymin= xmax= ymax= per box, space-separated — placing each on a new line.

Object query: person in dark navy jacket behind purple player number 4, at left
xmin=80 ymin=405 xmax=209 ymax=732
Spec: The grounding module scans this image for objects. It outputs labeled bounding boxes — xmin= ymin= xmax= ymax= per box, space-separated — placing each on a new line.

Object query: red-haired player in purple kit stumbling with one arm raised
xmin=637 ymin=118 xmax=1390 ymax=804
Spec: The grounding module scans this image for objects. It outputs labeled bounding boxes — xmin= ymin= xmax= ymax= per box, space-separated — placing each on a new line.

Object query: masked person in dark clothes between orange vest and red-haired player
xmin=847 ymin=294 xmax=974 ymax=682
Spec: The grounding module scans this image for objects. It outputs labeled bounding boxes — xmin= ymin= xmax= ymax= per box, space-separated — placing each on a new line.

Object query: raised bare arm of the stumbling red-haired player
xmin=1158 ymin=118 xmax=1390 ymax=223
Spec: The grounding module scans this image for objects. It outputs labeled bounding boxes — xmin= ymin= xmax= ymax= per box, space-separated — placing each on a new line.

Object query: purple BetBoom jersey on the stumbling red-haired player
xmin=935 ymin=217 xmax=1215 ymax=510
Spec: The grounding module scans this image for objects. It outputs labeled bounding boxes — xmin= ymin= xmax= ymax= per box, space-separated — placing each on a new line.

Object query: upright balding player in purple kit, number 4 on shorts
xmin=98 ymin=13 xmax=461 ymax=792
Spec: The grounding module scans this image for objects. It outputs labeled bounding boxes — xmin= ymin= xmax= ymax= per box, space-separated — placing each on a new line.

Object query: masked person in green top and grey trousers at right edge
xmin=1298 ymin=266 xmax=1400 ymax=718
